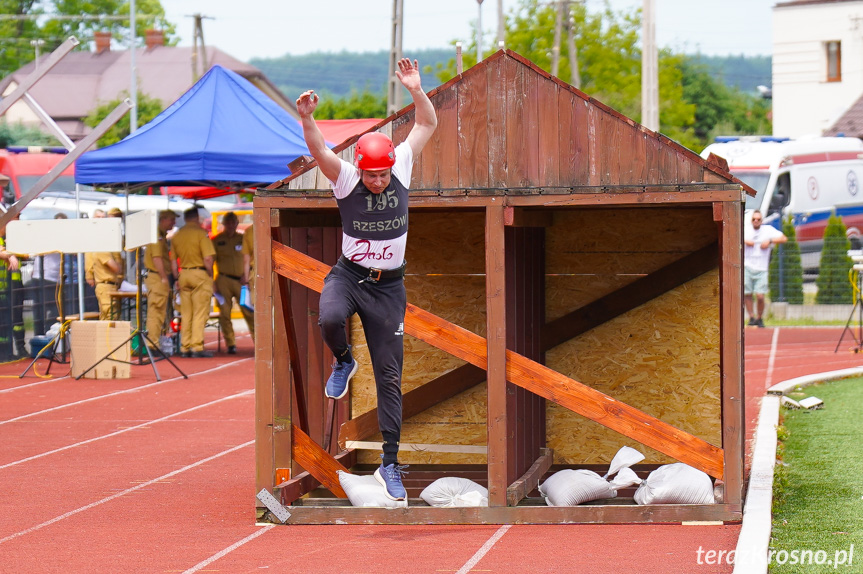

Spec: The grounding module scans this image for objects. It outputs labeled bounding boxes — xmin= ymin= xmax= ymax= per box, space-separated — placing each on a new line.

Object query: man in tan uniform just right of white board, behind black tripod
xmin=144 ymin=209 xmax=177 ymax=347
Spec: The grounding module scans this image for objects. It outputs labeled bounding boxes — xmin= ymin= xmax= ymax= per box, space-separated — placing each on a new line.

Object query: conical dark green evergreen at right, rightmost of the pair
xmin=815 ymin=213 xmax=853 ymax=305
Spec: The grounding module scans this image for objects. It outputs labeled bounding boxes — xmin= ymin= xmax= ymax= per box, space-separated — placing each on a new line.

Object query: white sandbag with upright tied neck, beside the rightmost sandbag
xmin=539 ymin=446 xmax=644 ymax=506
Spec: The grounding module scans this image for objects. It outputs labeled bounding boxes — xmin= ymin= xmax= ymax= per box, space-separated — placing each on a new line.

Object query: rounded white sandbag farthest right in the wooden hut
xmin=635 ymin=462 xmax=715 ymax=504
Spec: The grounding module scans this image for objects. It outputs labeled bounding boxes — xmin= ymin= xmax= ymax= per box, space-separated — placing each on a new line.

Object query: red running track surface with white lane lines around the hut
xmin=0 ymin=328 xmax=861 ymax=574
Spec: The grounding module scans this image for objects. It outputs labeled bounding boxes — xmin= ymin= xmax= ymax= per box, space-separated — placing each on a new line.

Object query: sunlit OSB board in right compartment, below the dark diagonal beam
xmin=546 ymin=271 xmax=722 ymax=464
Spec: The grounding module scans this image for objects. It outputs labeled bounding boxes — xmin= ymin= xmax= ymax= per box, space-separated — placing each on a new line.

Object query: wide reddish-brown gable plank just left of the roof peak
xmin=458 ymin=62 xmax=489 ymax=188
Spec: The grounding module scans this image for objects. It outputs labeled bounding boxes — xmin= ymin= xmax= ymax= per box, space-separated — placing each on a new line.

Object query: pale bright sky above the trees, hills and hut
xmin=161 ymin=0 xmax=776 ymax=62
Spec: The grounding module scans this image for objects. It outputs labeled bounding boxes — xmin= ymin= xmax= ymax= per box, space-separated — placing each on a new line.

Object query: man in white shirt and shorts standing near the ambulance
xmin=743 ymin=210 xmax=788 ymax=327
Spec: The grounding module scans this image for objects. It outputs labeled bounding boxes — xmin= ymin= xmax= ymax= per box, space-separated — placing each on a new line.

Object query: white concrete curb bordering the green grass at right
xmin=734 ymin=367 xmax=863 ymax=574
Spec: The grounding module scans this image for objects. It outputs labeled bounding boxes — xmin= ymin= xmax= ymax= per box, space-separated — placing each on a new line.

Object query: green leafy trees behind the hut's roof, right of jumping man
xmin=437 ymin=0 xmax=770 ymax=150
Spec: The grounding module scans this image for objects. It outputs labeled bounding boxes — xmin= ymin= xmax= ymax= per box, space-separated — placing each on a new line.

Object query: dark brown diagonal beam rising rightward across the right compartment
xmin=542 ymin=243 xmax=719 ymax=351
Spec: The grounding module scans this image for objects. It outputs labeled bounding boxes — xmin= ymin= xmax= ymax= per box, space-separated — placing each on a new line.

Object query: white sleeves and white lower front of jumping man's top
xmin=330 ymin=142 xmax=414 ymax=269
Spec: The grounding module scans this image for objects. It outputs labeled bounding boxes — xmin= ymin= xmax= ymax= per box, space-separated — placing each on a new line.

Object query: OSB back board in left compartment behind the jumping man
xmin=351 ymin=212 xmax=486 ymax=464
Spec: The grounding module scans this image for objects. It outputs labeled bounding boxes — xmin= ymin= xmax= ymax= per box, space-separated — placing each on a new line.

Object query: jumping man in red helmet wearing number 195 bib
xmin=297 ymin=58 xmax=437 ymax=500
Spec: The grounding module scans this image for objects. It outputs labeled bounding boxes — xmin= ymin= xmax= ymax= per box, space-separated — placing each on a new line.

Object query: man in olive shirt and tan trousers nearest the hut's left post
xmin=213 ymin=211 xmax=255 ymax=355
